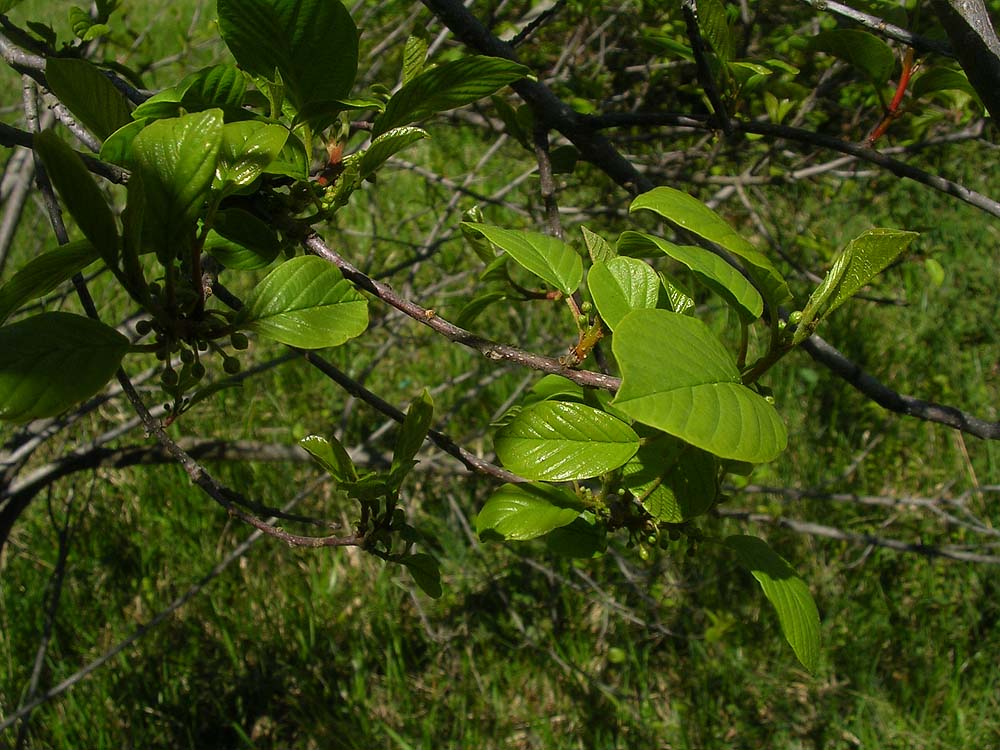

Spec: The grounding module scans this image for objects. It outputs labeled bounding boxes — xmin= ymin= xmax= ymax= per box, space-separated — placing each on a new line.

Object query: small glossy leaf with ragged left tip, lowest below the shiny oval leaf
xmin=476 ymin=484 xmax=582 ymax=541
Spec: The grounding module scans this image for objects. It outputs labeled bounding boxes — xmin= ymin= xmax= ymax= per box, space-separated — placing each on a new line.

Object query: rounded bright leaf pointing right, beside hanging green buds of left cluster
xmin=239 ymin=255 xmax=368 ymax=349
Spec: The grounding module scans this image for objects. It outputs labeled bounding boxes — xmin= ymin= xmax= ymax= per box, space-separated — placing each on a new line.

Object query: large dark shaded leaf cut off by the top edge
xmin=217 ymin=0 xmax=358 ymax=119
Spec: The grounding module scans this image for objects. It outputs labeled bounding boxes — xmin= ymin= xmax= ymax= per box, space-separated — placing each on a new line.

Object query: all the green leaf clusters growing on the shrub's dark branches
xmin=0 ymin=0 xmax=996 ymax=744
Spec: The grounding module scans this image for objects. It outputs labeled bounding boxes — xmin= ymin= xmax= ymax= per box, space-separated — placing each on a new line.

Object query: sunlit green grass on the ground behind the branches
xmin=0 ymin=3 xmax=1000 ymax=749
